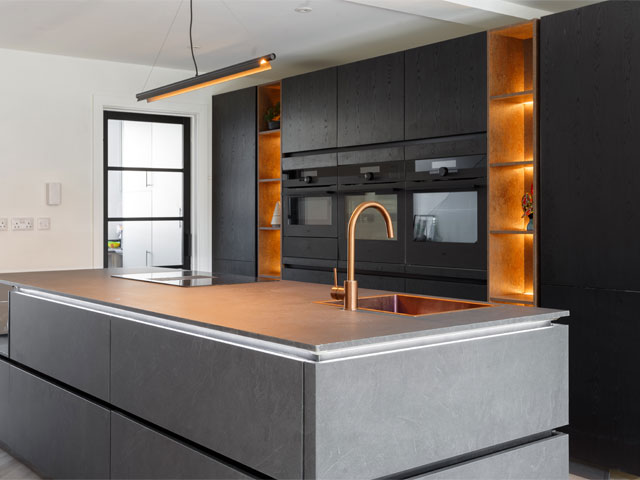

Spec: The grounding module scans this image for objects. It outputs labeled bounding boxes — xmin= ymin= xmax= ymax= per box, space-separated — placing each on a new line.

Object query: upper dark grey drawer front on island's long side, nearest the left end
xmin=9 ymin=292 xmax=110 ymax=401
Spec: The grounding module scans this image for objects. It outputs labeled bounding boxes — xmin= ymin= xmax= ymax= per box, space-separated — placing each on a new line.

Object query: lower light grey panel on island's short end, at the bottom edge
xmin=411 ymin=434 xmax=569 ymax=480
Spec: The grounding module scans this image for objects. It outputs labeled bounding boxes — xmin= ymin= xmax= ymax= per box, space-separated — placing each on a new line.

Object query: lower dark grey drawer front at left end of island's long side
xmin=7 ymin=366 xmax=110 ymax=479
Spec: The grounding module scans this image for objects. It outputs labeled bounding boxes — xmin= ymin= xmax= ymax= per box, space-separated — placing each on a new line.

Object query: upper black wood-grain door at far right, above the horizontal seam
xmin=540 ymin=1 xmax=640 ymax=291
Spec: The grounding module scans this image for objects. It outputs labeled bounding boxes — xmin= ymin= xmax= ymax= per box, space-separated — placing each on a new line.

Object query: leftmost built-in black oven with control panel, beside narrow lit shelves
xmin=282 ymin=154 xmax=338 ymax=237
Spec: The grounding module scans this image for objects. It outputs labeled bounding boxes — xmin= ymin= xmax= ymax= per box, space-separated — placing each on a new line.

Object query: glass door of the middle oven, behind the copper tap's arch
xmin=338 ymin=186 xmax=404 ymax=263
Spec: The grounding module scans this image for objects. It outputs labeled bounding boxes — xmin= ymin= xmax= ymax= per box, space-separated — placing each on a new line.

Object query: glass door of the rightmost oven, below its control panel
xmin=406 ymin=182 xmax=487 ymax=270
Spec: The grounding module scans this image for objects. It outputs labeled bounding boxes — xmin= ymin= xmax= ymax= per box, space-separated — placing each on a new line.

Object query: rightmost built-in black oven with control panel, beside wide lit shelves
xmin=405 ymin=154 xmax=487 ymax=270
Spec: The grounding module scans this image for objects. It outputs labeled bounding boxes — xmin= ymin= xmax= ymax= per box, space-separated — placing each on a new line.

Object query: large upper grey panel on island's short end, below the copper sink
xmin=305 ymin=325 xmax=569 ymax=479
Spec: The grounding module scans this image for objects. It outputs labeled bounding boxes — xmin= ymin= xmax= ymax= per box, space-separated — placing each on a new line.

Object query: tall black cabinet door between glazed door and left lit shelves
xmin=211 ymin=87 xmax=257 ymax=275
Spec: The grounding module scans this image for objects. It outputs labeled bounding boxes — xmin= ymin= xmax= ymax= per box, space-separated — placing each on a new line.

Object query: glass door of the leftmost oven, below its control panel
xmin=284 ymin=188 xmax=337 ymax=237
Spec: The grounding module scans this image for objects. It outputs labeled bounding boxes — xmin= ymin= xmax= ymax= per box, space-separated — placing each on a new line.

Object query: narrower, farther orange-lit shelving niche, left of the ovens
xmin=258 ymin=82 xmax=282 ymax=278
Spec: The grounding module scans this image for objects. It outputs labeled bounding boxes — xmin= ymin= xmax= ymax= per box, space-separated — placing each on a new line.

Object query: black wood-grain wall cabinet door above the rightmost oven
xmin=405 ymin=32 xmax=487 ymax=140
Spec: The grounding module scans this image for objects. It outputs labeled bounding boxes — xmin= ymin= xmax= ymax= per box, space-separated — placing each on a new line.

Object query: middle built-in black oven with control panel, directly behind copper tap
xmin=338 ymin=160 xmax=405 ymax=264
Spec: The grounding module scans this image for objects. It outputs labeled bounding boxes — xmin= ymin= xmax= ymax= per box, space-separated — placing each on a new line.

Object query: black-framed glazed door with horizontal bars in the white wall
xmin=103 ymin=111 xmax=191 ymax=269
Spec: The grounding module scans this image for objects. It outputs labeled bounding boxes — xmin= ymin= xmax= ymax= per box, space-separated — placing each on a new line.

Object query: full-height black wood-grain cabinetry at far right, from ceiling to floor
xmin=540 ymin=1 xmax=640 ymax=474
